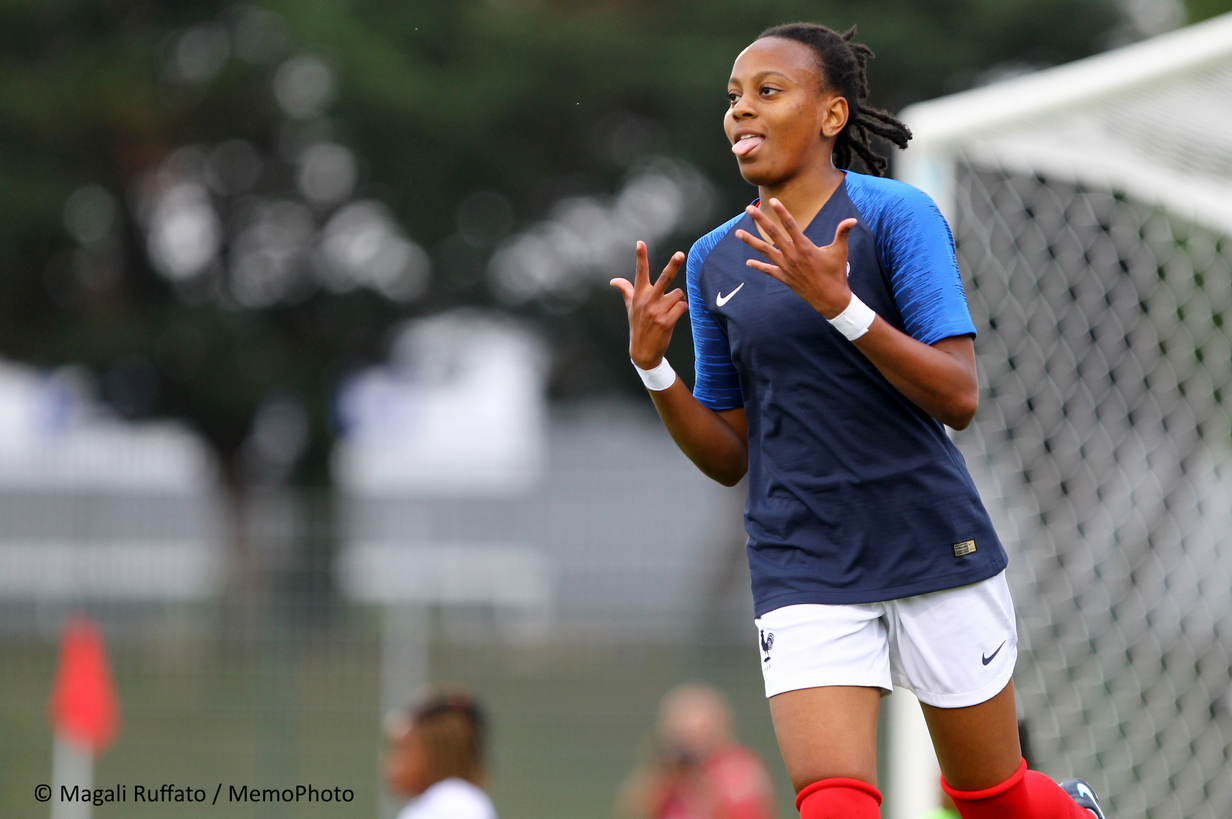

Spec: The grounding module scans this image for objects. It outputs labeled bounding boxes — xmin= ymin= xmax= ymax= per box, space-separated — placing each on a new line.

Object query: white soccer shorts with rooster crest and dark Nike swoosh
xmin=755 ymin=571 xmax=1018 ymax=708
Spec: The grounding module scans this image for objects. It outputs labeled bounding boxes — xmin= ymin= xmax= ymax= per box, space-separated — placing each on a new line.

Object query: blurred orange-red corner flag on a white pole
xmin=51 ymin=617 xmax=120 ymax=754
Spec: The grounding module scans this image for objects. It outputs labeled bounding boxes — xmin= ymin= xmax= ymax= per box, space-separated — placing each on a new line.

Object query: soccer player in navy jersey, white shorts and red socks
xmin=612 ymin=23 xmax=1103 ymax=819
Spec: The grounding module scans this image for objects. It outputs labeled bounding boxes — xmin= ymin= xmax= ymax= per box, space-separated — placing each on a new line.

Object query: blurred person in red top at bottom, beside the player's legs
xmin=618 ymin=685 xmax=775 ymax=819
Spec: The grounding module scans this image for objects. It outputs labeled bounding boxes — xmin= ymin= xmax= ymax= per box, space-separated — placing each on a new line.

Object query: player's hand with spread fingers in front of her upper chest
xmin=736 ymin=200 xmax=856 ymax=319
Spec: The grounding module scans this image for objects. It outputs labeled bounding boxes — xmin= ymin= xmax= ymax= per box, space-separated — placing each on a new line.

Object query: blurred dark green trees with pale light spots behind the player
xmin=0 ymin=0 xmax=1133 ymax=483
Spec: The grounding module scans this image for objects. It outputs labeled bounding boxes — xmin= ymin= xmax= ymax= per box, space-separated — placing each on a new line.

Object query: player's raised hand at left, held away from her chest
xmin=611 ymin=241 xmax=689 ymax=369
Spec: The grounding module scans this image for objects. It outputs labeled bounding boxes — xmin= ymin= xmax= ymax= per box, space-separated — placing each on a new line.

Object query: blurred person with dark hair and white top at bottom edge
xmin=384 ymin=691 xmax=496 ymax=819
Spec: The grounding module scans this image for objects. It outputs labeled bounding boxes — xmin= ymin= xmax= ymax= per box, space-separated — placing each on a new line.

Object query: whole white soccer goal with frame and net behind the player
xmin=899 ymin=15 xmax=1232 ymax=819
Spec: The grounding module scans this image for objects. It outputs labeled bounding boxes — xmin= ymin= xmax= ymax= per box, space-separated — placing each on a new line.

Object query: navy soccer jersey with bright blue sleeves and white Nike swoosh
xmin=686 ymin=172 xmax=1007 ymax=616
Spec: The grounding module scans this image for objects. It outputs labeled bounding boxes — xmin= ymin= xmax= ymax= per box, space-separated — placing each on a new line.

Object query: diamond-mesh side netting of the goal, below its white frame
xmin=954 ymin=161 xmax=1232 ymax=819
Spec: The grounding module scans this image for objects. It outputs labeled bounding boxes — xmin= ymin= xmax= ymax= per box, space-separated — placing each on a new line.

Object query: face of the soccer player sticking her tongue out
xmin=723 ymin=37 xmax=846 ymax=186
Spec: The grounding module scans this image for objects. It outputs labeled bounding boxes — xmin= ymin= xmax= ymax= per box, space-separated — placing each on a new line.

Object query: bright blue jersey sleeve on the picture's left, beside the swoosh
xmin=685 ymin=214 xmax=744 ymax=410
